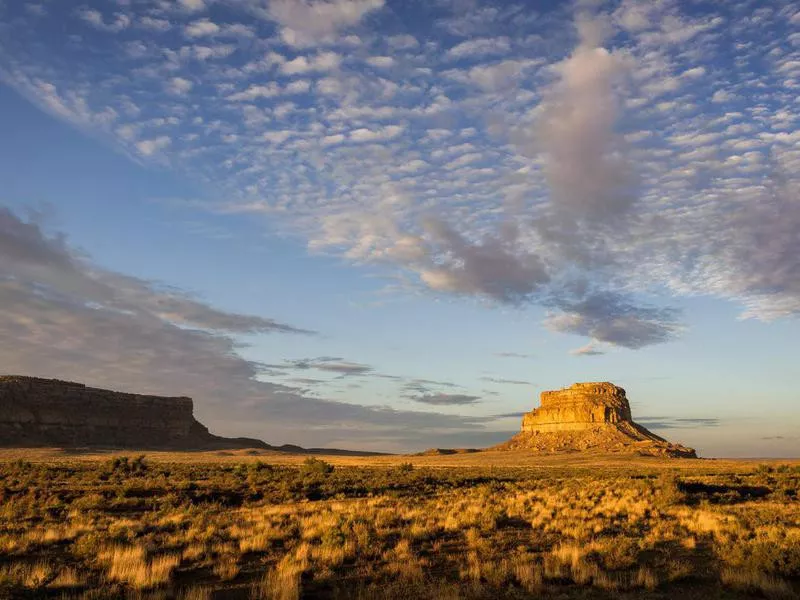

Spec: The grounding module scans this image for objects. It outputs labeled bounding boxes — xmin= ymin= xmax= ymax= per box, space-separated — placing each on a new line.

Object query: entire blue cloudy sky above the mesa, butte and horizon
xmin=0 ymin=0 xmax=800 ymax=457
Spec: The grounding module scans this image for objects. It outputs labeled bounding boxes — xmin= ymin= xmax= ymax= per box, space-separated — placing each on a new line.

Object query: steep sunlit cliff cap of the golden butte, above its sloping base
xmin=522 ymin=382 xmax=633 ymax=433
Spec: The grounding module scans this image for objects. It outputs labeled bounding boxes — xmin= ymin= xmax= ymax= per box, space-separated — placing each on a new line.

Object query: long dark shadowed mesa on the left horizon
xmin=0 ymin=375 xmax=270 ymax=449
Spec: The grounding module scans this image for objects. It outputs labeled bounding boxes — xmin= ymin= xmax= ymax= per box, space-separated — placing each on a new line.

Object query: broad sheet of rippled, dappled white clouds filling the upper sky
xmin=0 ymin=0 xmax=800 ymax=354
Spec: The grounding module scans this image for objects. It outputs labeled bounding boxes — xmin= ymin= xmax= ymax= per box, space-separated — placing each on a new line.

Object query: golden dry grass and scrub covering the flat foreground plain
xmin=0 ymin=455 xmax=800 ymax=600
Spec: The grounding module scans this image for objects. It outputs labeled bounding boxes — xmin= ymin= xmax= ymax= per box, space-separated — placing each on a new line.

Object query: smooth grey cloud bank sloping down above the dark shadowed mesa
xmin=0 ymin=207 xmax=491 ymax=449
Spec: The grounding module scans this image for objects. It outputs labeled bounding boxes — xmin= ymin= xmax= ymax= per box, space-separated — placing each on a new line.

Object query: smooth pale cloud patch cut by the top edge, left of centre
xmin=266 ymin=0 xmax=384 ymax=46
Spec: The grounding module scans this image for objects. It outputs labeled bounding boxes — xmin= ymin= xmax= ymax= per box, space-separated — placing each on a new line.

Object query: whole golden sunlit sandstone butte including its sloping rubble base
xmin=497 ymin=382 xmax=697 ymax=458
